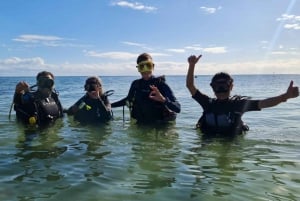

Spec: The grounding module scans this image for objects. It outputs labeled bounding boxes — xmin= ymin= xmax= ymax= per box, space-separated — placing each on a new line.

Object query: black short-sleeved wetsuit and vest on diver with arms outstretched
xmin=193 ymin=90 xmax=260 ymax=136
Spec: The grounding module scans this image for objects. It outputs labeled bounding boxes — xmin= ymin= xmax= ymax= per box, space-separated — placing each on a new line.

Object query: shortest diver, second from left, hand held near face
xmin=66 ymin=76 xmax=112 ymax=124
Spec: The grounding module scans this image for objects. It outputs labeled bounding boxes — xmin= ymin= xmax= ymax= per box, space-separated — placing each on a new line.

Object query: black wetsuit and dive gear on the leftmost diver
xmin=14 ymin=91 xmax=63 ymax=126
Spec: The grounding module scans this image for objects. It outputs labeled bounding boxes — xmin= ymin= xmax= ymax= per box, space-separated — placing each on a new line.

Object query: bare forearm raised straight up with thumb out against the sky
xmin=186 ymin=55 xmax=202 ymax=96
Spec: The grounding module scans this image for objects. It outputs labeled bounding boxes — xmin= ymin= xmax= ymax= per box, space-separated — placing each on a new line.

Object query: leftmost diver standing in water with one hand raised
xmin=13 ymin=71 xmax=63 ymax=126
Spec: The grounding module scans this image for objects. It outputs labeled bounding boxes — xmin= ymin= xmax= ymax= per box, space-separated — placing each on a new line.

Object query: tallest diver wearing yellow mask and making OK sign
xmin=111 ymin=53 xmax=181 ymax=124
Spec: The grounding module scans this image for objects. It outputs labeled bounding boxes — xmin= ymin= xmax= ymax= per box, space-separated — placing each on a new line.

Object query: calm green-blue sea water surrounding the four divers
xmin=0 ymin=75 xmax=300 ymax=201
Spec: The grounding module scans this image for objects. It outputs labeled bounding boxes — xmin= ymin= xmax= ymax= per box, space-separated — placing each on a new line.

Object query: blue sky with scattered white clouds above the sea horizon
xmin=0 ymin=0 xmax=300 ymax=76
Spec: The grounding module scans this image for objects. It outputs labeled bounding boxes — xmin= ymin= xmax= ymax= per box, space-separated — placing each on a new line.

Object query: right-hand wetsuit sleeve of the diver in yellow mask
xmin=161 ymin=83 xmax=181 ymax=113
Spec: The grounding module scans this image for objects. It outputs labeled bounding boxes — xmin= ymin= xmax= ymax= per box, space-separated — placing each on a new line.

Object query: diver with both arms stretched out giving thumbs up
xmin=186 ymin=55 xmax=299 ymax=136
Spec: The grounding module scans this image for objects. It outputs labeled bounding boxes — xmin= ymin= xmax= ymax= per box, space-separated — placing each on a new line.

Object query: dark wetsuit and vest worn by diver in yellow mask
xmin=111 ymin=76 xmax=180 ymax=124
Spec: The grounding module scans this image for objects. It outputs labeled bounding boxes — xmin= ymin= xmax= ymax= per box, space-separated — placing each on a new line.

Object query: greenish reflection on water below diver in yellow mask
xmin=128 ymin=125 xmax=178 ymax=194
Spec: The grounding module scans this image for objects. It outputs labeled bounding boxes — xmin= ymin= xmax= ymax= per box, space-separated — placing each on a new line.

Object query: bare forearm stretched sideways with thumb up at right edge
xmin=258 ymin=81 xmax=299 ymax=109
